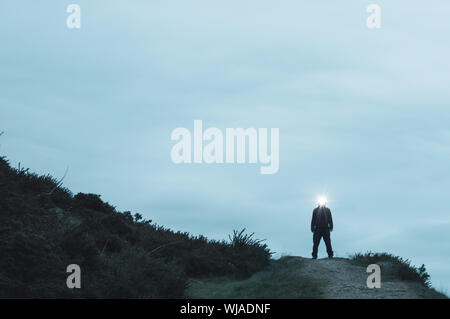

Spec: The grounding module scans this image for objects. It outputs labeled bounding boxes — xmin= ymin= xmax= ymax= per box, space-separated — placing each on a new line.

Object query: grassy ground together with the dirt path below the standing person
xmin=186 ymin=257 xmax=443 ymax=299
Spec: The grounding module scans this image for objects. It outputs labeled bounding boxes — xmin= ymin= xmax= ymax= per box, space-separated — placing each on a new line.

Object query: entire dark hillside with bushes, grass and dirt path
xmin=0 ymin=158 xmax=443 ymax=298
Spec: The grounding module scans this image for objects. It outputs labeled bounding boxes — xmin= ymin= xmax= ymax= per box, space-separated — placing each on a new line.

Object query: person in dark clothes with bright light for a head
xmin=311 ymin=201 xmax=333 ymax=259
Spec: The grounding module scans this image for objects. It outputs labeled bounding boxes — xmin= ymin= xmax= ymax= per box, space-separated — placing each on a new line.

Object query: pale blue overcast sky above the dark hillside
xmin=0 ymin=0 xmax=450 ymax=289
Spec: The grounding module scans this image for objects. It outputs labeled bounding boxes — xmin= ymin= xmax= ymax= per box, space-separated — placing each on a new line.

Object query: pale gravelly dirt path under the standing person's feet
xmin=289 ymin=257 xmax=423 ymax=299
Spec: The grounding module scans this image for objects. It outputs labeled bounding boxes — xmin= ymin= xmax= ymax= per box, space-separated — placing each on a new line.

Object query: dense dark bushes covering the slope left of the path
xmin=0 ymin=158 xmax=271 ymax=298
